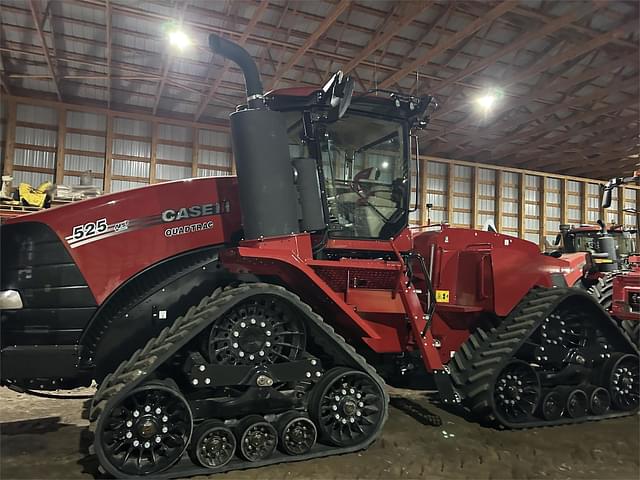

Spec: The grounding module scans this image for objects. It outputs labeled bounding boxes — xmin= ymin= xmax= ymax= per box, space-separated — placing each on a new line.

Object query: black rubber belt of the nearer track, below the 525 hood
xmin=89 ymin=283 xmax=389 ymax=478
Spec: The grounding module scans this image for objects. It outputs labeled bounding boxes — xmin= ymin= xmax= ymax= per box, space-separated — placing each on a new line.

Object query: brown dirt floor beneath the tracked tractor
xmin=0 ymin=388 xmax=640 ymax=480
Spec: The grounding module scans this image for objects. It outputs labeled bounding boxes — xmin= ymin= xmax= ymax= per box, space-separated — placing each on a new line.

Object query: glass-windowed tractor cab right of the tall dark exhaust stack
xmin=265 ymin=84 xmax=435 ymax=240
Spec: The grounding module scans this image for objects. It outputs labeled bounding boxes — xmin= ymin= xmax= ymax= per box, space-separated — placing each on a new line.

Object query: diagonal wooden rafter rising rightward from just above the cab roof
xmin=379 ymin=0 xmax=517 ymax=88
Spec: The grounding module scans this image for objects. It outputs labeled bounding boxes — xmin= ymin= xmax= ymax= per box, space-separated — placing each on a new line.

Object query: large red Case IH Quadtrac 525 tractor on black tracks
xmin=1 ymin=36 xmax=639 ymax=477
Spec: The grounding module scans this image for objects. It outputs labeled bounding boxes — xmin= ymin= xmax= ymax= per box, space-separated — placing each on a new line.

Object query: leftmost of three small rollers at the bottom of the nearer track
xmin=189 ymin=420 xmax=236 ymax=468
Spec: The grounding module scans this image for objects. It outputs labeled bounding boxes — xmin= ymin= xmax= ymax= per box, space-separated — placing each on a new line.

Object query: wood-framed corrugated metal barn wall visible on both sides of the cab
xmin=0 ymin=96 xmax=640 ymax=248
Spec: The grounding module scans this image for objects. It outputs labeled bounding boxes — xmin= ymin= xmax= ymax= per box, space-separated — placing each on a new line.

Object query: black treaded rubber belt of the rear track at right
xmin=449 ymin=288 xmax=637 ymax=428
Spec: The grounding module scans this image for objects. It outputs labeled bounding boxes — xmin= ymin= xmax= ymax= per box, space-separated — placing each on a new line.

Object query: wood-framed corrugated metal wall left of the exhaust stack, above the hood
xmin=0 ymin=97 xmax=233 ymax=192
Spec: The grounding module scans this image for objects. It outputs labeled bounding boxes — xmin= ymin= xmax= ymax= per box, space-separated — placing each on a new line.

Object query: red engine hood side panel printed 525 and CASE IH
xmin=7 ymin=177 xmax=241 ymax=304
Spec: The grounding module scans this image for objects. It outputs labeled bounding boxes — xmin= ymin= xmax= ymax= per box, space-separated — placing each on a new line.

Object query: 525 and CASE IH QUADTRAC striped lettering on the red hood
xmin=65 ymin=200 xmax=230 ymax=248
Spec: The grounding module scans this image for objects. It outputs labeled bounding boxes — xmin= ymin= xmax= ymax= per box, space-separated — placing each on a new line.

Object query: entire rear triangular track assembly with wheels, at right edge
xmin=450 ymin=288 xmax=640 ymax=428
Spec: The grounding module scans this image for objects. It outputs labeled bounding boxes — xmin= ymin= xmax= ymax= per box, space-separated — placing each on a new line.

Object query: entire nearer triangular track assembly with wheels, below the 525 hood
xmin=90 ymin=283 xmax=389 ymax=478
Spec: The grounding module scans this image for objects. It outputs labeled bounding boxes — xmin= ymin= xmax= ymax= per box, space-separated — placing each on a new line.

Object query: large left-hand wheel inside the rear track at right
xmin=493 ymin=360 xmax=542 ymax=423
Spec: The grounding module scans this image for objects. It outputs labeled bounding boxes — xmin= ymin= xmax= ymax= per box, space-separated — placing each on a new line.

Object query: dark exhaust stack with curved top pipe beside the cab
xmin=209 ymin=35 xmax=300 ymax=240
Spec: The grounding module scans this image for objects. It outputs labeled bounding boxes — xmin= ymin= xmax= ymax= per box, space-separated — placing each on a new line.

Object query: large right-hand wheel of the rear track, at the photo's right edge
xmin=603 ymin=353 xmax=640 ymax=412
